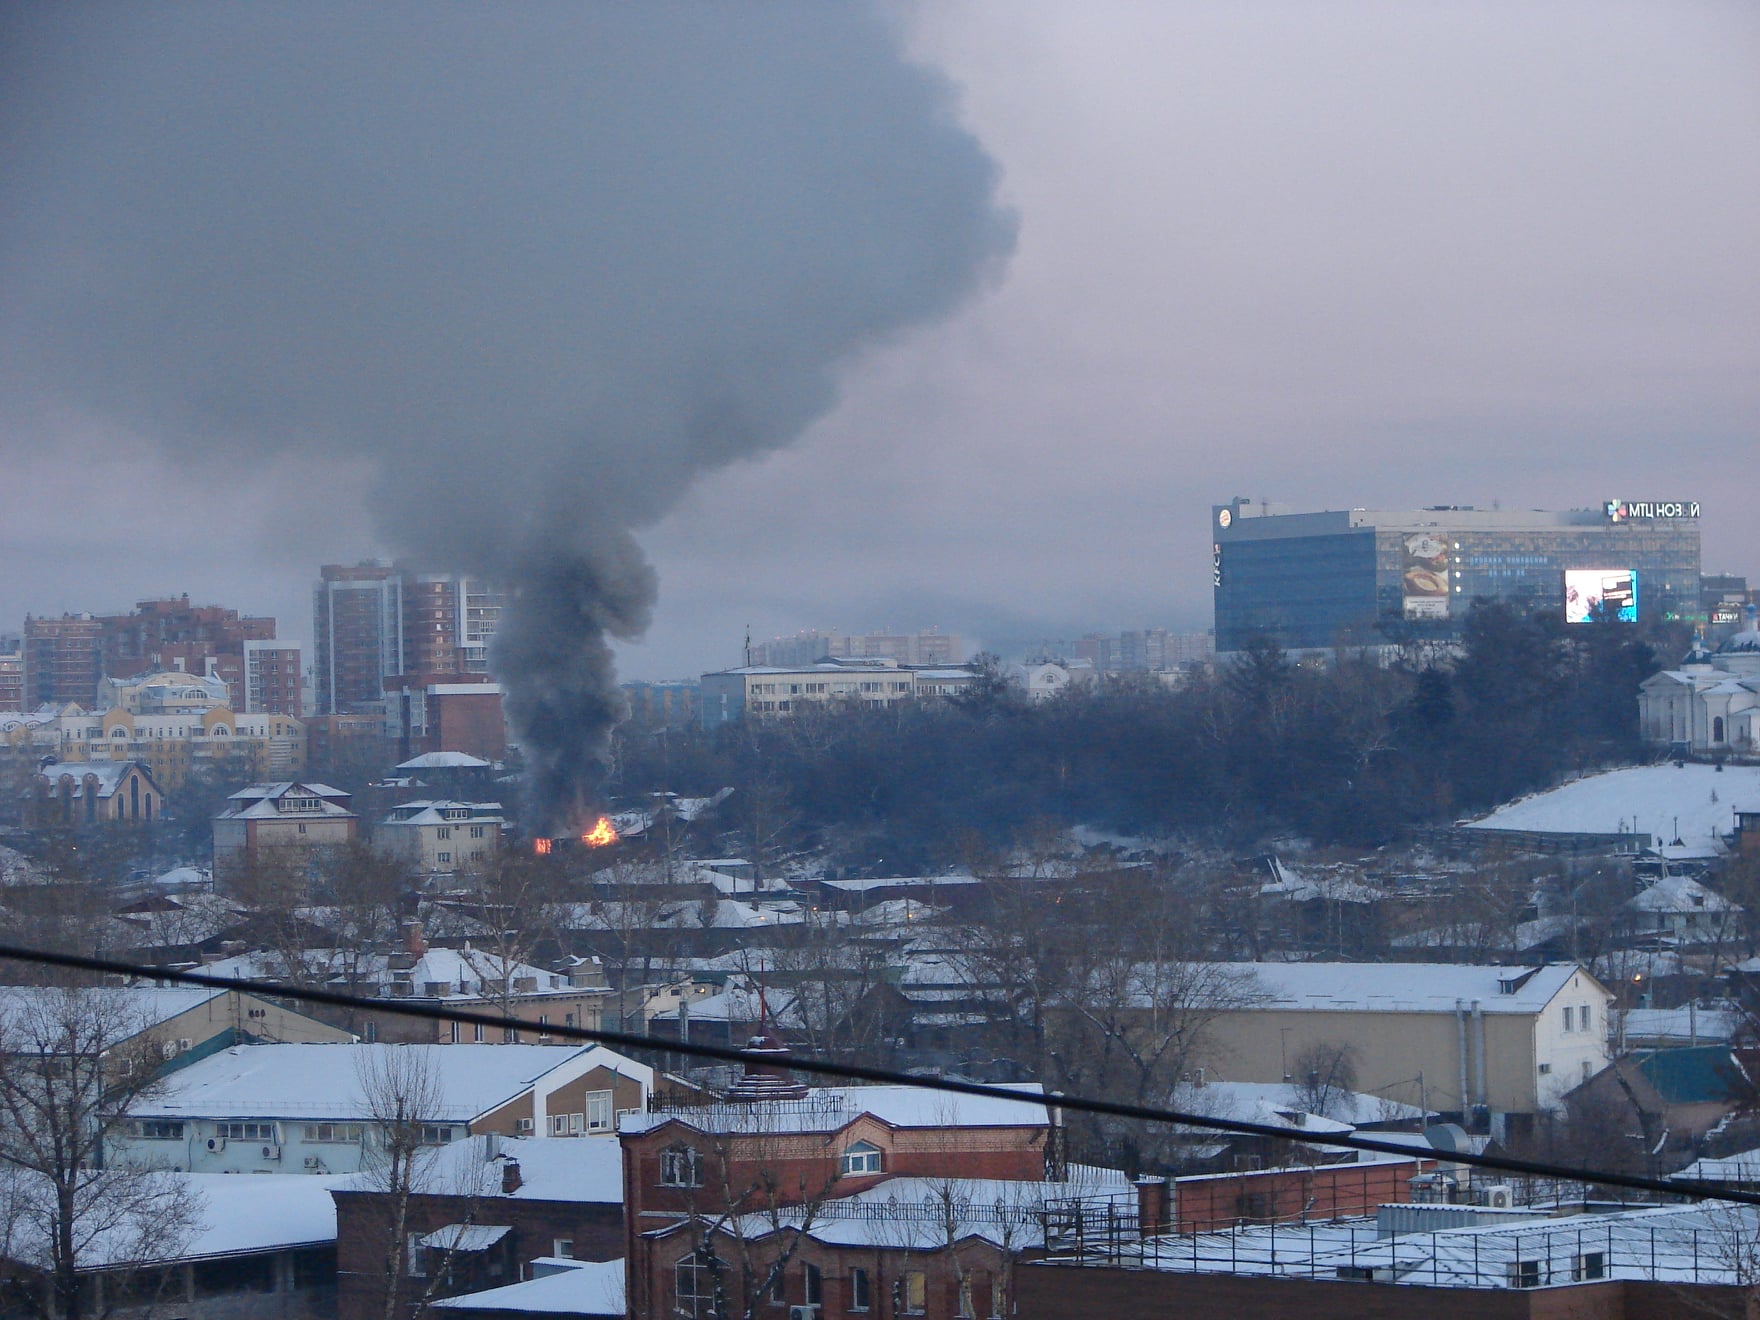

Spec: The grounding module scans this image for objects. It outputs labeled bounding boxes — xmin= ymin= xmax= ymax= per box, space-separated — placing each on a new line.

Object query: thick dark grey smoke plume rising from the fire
xmin=0 ymin=4 xmax=1012 ymax=824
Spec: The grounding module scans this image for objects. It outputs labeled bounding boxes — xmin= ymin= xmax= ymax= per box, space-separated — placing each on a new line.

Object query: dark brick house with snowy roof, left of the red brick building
xmin=334 ymin=1135 xmax=625 ymax=1320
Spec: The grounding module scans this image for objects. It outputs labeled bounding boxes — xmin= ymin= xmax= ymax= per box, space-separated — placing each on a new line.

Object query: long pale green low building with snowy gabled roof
xmin=116 ymin=1044 xmax=653 ymax=1174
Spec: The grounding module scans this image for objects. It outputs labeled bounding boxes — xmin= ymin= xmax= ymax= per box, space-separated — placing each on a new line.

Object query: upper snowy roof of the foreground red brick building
xmin=618 ymin=1082 xmax=1051 ymax=1133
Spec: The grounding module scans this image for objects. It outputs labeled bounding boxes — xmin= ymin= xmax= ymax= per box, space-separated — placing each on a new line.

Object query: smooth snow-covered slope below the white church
xmin=1468 ymin=766 xmax=1760 ymax=857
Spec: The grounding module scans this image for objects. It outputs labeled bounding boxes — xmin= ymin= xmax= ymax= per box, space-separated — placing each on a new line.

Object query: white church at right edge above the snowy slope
xmin=1639 ymin=607 xmax=1760 ymax=757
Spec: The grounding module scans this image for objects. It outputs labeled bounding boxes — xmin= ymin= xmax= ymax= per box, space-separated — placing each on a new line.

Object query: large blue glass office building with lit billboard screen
xmin=1211 ymin=500 xmax=1700 ymax=651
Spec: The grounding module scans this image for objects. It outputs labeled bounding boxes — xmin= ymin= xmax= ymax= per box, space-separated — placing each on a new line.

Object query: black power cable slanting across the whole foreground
xmin=0 ymin=945 xmax=1760 ymax=1206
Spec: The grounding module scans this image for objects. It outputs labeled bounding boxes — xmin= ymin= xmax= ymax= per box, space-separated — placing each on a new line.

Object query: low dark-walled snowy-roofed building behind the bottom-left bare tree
xmin=0 ymin=1172 xmax=350 ymax=1320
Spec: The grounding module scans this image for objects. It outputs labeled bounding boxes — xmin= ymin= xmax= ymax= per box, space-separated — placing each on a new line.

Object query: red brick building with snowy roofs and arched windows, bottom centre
xmin=620 ymin=1070 xmax=1128 ymax=1320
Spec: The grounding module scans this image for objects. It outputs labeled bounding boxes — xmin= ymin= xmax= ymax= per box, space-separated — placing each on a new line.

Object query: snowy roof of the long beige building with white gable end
xmin=1220 ymin=963 xmax=1607 ymax=1014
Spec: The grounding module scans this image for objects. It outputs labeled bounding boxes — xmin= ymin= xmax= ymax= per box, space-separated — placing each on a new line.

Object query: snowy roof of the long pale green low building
xmin=130 ymin=1044 xmax=653 ymax=1123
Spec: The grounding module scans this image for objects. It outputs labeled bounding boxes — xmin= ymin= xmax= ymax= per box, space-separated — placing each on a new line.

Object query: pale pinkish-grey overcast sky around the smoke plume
xmin=0 ymin=0 xmax=1760 ymax=678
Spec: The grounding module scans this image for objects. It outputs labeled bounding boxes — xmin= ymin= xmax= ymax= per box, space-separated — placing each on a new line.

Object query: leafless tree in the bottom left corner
xmin=0 ymin=987 xmax=201 ymax=1320
